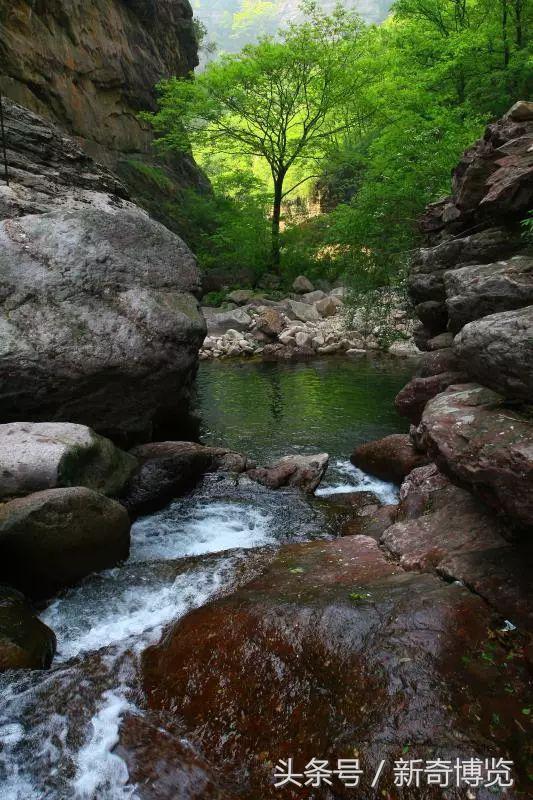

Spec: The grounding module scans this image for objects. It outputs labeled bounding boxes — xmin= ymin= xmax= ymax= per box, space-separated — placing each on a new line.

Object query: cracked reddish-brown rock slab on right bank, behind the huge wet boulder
xmin=378 ymin=464 xmax=533 ymax=633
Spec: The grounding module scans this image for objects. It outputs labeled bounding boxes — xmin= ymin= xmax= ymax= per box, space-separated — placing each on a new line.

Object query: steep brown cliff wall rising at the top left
xmin=0 ymin=0 xmax=209 ymax=214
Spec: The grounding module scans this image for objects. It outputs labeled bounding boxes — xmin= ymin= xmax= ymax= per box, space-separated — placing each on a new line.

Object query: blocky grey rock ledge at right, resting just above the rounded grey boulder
xmin=444 ymin=256 xmax=533 ymax=332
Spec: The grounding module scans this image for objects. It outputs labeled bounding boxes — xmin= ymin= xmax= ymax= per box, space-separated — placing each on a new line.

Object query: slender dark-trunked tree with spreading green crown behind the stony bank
xmin=146 ymin=3 xmax=364 ymax=270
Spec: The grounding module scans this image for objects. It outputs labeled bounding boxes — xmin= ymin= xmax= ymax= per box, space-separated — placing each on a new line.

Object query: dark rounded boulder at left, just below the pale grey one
xmin=0 ymin=487 xmax=130 ymax=598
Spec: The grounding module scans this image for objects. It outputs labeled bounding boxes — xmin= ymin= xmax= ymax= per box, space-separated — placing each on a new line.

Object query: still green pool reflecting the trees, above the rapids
xmin=198 ymin=357 xmax=412 ymax=462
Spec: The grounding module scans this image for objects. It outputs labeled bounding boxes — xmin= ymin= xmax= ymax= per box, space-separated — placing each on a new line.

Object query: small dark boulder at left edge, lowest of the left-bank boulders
xmin=0 ymin=586 xmax=56 ymax=672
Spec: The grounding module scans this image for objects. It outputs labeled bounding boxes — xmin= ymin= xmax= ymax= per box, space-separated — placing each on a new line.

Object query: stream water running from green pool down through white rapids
xmin=0 ymin=359 xmax=408 ymax=800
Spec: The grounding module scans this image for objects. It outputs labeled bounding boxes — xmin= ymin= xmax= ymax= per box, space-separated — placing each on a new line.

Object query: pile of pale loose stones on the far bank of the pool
xmin=200 ymin=276 xmax=419 ymax=360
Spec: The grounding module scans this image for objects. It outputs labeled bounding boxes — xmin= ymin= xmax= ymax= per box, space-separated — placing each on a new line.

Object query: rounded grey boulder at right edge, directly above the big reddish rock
xmin=454 ymin=306 xmax=533 ymax=401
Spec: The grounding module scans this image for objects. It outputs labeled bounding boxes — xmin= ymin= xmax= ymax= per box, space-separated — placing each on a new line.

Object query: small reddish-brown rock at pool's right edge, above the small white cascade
xmin=350 ymin=433 xmax=429 ymax=483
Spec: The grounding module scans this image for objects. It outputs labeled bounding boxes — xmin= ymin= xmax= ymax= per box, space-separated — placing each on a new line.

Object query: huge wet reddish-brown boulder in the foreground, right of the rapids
xmin=138 ymin=536 xmax=529 ymax=800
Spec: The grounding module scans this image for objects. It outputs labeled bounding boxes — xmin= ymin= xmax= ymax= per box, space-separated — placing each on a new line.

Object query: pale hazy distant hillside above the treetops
xmin=191 ymin=0 xmax=393 ymax=52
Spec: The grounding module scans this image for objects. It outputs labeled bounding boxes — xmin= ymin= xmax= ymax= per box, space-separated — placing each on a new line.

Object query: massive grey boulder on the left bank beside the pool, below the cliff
xmin=0 ymin=106 xmax=205 ymax=437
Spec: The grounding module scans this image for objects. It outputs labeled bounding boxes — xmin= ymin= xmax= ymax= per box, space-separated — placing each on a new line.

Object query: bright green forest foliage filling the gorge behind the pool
xmin=142 ymin=0 xmax=533 ymax=301
